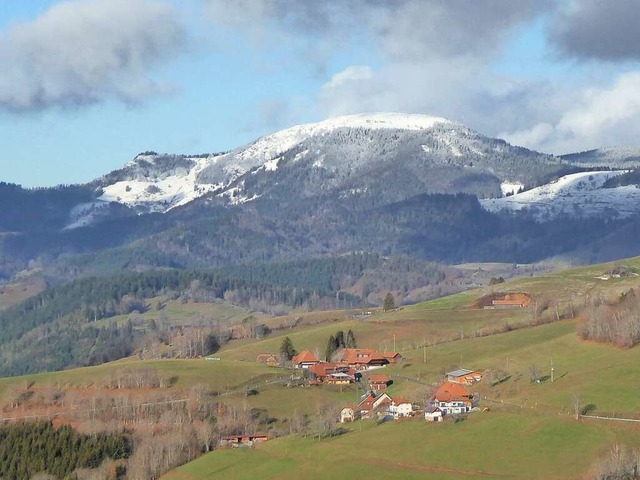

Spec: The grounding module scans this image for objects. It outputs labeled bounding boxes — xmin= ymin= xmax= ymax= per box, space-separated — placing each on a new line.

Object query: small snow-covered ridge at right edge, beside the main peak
xmin=480 ymin=170 xmax=640 ymax=220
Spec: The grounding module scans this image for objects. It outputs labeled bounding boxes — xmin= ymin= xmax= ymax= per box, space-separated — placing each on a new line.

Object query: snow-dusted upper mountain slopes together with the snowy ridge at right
xmin=56 ymin=113 xmax=640 ymax=228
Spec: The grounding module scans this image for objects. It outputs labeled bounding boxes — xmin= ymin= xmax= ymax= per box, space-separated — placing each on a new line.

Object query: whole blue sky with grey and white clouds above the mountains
xmin=0 ymin=0 xmax=640 ymax=187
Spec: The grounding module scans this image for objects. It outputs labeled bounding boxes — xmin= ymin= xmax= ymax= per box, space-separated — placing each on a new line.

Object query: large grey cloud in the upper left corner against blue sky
xmin=0 ymin=0 xmax=185 ymax=111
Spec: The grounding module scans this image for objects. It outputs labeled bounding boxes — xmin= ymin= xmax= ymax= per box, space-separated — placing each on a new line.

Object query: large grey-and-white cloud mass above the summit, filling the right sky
xmin=207 ymin=0 xmax=640 ymax=153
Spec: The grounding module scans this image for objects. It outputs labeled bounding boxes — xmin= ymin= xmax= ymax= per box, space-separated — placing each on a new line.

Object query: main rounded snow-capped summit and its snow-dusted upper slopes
xmin=80 ymin=113 xmax=565 ymax=227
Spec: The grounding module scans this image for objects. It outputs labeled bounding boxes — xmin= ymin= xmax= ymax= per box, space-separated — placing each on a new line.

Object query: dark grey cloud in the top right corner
xmin=550 ymin=0 xmax=640 ymax=61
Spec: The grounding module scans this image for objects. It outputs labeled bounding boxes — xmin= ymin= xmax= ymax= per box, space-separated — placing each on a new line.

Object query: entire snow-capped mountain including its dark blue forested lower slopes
xmin=0 ymin=113 xmax=640 ymax=277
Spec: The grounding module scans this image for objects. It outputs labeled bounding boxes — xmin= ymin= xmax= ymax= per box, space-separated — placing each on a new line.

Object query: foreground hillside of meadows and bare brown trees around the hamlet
xmin=0 ymin=255 xmax=640 ymax=479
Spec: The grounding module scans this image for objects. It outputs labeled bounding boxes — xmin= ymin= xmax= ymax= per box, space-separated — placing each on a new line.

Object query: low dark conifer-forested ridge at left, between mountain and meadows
xmin=0 ymin=253 xmax=450 ymax=376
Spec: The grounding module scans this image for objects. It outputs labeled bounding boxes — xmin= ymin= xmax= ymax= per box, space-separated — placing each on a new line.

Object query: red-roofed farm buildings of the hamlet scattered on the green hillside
xmin=221 ymin=293 xmax=532 ymax=447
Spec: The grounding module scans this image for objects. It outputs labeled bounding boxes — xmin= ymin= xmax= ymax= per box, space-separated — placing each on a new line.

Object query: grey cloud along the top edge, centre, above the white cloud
xmin=208 ymin=0 xmax=551 ymax=60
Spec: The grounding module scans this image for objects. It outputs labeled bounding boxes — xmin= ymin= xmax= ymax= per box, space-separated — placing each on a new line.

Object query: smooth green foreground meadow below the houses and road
xmin=162 ymin=412 xmax=638 ymax=480
